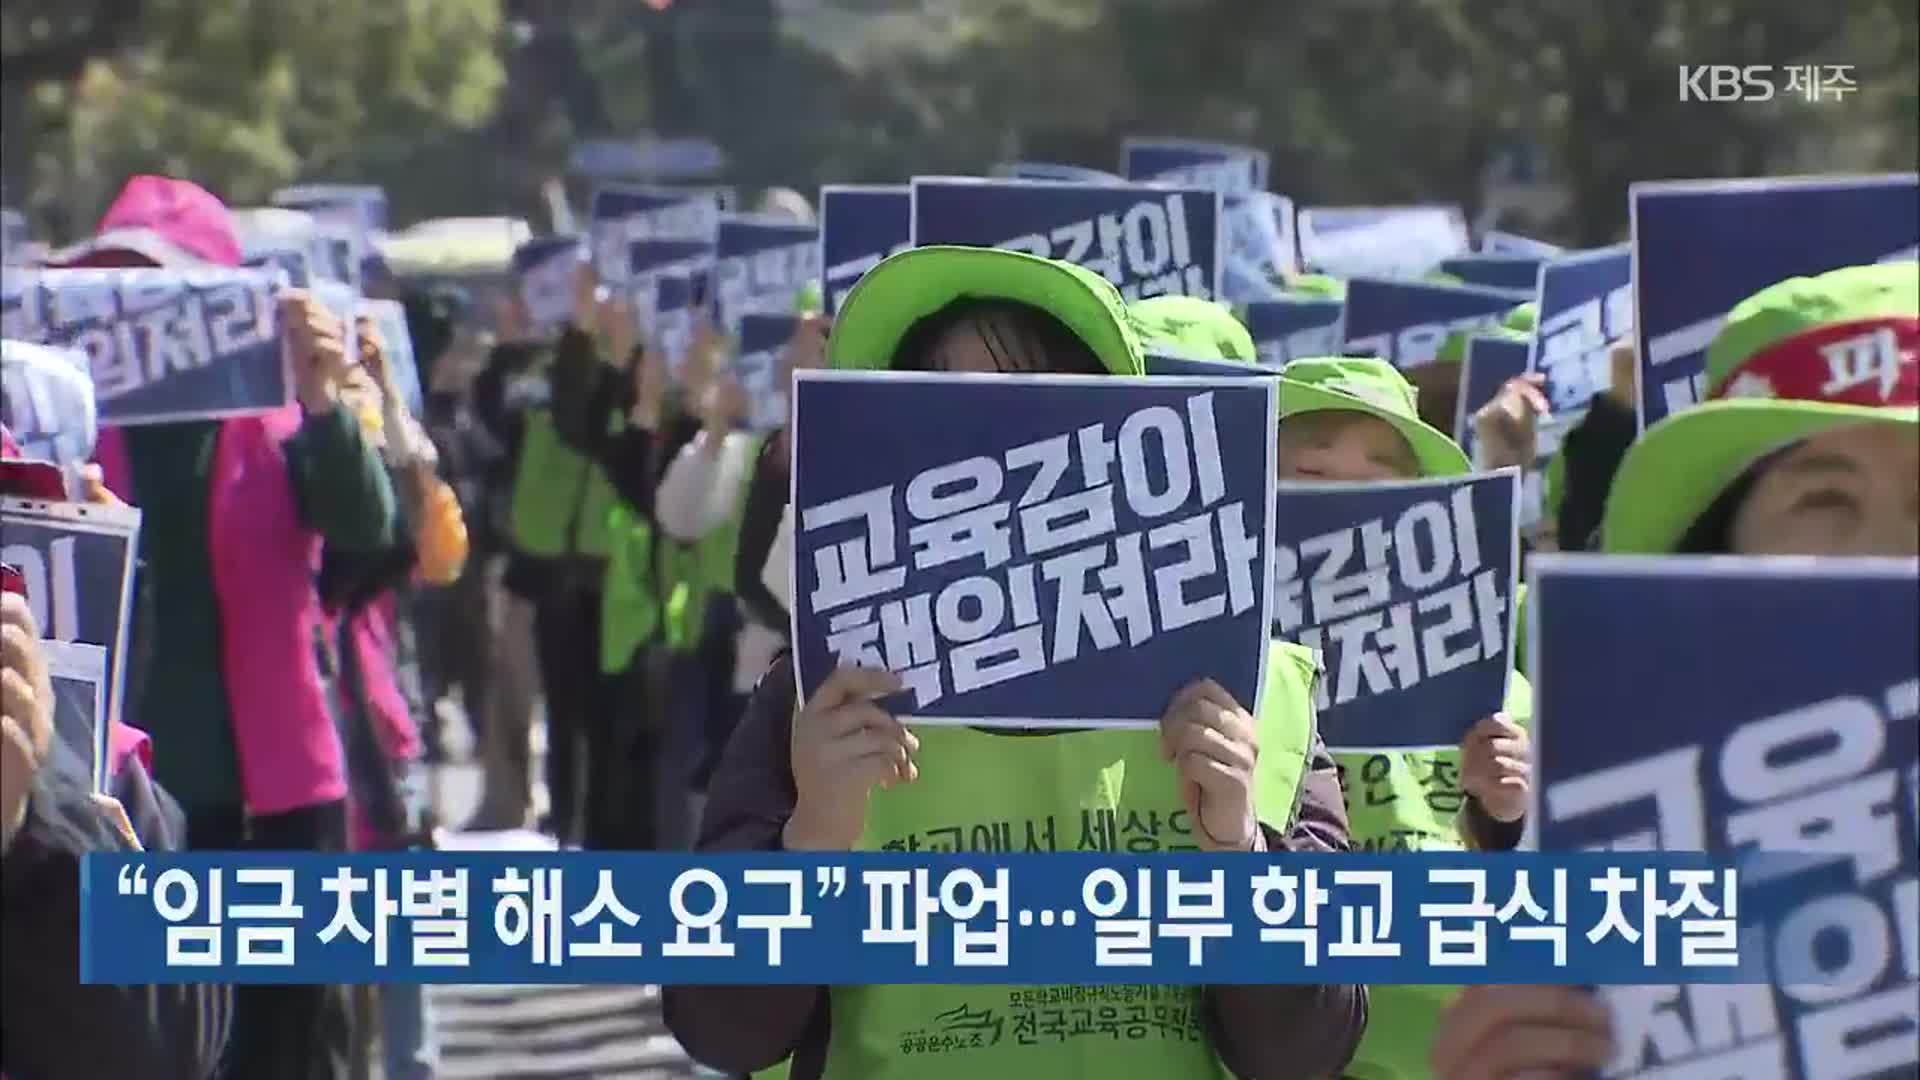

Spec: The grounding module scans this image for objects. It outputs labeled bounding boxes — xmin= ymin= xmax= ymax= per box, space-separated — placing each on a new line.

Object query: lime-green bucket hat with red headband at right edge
xmin=1601 ymin=263 xmax=1920 ymax=553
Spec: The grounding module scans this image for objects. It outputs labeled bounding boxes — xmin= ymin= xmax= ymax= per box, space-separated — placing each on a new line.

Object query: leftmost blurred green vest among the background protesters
xmin=513 ymin=409 xmax=624 ymax=559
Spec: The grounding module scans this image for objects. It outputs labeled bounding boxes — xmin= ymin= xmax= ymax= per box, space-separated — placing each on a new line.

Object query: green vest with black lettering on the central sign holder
xmin=756 ymin=642 xmax=1317 ymax=1080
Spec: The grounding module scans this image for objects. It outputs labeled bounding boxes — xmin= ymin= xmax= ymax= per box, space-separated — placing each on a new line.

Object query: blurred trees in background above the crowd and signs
xmin=0 ymin=0 xmax=1920 ymax=244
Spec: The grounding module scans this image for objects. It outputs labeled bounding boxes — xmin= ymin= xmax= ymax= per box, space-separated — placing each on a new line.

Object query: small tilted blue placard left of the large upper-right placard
xmin=1526 ymin=244 xmax=1634 ymax=457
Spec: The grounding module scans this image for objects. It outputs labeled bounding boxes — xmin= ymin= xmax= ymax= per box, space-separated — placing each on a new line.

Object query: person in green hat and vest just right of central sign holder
xmin=1279 ymin=357 xmax=1530 ymax=1078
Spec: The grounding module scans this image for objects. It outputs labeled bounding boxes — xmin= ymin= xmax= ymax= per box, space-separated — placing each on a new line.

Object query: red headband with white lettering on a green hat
xmin=1709 ymin=315 xmax=1920 ymax=407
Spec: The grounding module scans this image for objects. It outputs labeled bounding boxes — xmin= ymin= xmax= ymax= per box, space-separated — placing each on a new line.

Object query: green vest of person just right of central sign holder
xmin=1334 ymin=671 xmax=1534 ymax=1080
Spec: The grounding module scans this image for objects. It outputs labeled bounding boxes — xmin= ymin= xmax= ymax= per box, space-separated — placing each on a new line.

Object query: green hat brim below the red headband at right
xmin=1601 ymin=398 xmax=1920 ymax=555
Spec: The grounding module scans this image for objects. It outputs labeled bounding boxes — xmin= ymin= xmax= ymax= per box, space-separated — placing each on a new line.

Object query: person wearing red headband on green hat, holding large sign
xmin=1430 ymin=261 xmax=1920 ymax=1080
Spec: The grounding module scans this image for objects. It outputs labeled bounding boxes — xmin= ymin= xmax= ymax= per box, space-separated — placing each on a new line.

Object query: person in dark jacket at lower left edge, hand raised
xmin=0 ymin=592 xmax=232 ymax=1080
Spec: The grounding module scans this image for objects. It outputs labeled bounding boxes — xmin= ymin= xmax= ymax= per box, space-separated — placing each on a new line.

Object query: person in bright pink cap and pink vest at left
xmin=52 ymin=177 xmax=394 ymax=1078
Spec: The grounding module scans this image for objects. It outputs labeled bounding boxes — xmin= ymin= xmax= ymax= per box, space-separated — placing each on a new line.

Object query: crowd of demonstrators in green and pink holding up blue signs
xmin=0 ymin=161 xmax=1920 ymax=1080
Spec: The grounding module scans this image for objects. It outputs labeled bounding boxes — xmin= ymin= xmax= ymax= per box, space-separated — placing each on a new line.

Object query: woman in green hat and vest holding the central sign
xmin=664 ymin=246 xmax=1367 ymax=1080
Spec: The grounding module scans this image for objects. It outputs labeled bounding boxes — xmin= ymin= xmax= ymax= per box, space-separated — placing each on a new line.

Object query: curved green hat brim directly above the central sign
xmin=828 ymin=246 xmax=1146 ymax=375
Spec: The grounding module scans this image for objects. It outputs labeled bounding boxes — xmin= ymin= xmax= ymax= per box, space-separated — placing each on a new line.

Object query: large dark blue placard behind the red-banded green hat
xmin=1628 ymin=173 xmax=1920 ymax=430
